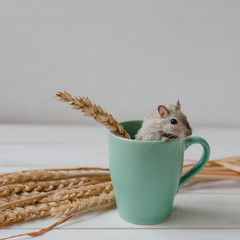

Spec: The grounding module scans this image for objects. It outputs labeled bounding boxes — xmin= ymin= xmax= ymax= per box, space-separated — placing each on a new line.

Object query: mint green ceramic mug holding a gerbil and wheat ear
xmin=108 ymin=120 xmax=210 ymax=224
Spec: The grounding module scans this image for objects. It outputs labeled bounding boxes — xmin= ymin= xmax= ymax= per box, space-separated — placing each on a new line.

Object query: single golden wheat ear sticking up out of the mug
xmin=55 ymin=91 xmax=131 ymax=139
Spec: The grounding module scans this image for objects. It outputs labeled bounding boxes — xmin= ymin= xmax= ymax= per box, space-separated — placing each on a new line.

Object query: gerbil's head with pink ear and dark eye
xmin=158 ymin=100 xmax=192 ymax=138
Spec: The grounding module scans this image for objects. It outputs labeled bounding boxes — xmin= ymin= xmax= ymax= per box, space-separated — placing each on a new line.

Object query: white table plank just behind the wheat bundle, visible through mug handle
xmin=0 ymin=142 xmax=240 ymax=166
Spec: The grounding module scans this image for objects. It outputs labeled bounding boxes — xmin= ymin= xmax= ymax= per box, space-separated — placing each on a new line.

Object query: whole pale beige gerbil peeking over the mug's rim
xmin=135 ymin=101 xmax=192 ymax=142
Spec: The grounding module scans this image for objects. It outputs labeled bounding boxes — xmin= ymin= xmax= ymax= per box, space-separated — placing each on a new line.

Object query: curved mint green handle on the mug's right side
xmin=178 ymin=137 xmax=210 ymax=190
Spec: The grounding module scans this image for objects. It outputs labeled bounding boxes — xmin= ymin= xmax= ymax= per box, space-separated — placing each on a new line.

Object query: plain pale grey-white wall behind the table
xmin=0 ymin=0 xmax=240 ymax=126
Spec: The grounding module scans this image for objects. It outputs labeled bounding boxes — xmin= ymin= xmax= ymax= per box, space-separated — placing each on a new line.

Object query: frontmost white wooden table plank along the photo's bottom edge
xmin=0 ymin=229 xmax=240 ymax=240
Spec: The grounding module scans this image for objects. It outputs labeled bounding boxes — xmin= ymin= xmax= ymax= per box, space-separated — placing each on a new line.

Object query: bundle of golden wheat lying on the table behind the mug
xmin=0 ymin=157 xmax=240 ymax=229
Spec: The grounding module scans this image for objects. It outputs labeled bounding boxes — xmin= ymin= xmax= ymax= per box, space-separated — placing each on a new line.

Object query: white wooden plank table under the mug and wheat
xmin=0 ymin=125 xmax=240 ymax=240
